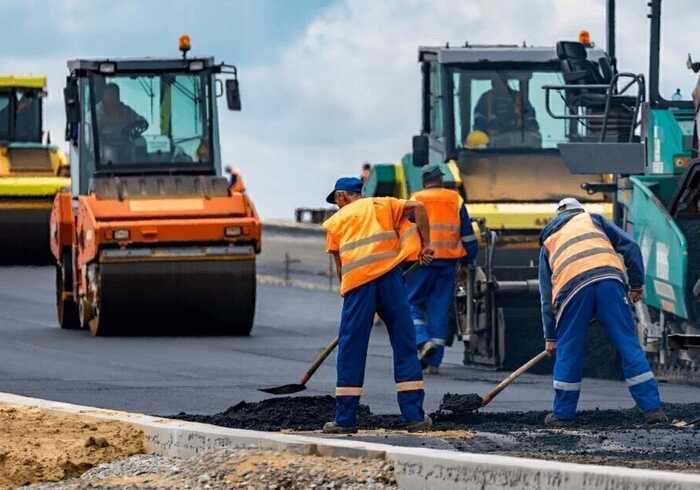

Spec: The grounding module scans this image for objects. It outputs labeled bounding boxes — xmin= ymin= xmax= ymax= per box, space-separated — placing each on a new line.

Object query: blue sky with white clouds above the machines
xmin=0 ymin=0 xmax=700 ymax=219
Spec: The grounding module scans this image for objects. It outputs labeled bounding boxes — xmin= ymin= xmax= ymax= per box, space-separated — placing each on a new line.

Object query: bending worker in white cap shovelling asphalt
xmin=539 ymin=198 xmax=668 ymax=426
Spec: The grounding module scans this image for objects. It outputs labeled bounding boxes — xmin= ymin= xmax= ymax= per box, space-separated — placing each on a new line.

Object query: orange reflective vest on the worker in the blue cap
xmin=323 ymin=197 xmax=420 ymax=295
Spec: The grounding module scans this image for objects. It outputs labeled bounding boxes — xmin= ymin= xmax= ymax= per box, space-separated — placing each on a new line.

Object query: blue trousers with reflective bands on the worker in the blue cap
xmin=335 ymin=267 xmax=425 ymax=427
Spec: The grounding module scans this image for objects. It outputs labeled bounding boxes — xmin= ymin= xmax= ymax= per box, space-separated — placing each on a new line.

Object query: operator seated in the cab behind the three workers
xmin=473 ymin=73 xmax=540 ymax=147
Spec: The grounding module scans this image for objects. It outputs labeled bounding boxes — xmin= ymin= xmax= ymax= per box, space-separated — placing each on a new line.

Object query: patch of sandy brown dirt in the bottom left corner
xmin=0 ymin=405 xmax=144 ymax=489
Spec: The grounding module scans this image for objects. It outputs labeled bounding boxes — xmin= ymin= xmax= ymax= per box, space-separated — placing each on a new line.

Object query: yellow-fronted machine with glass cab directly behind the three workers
xmin=365 ymin=43 xmax=628 ymax=371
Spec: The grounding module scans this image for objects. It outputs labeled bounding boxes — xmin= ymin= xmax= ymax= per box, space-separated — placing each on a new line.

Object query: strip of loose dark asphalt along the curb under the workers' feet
xmin=176 ymin=394 xmax=700 ymax=472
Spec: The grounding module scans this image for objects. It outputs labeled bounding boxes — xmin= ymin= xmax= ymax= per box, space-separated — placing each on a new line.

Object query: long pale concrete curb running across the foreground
xmin=0 ymin=393 xmax=700 ymax=490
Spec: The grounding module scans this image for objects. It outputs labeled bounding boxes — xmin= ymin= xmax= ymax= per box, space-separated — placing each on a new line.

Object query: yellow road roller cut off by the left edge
xmin=0 ymin=76 xmax=70 ymax=264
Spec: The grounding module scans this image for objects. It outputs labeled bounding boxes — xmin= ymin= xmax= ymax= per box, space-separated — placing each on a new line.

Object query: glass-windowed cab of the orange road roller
xmin=64 ymin=57 xmax=240 ymax=195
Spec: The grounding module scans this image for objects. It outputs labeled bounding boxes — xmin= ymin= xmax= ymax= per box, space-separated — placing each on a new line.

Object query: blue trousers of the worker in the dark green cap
xmin=406 ymin=260 xmax=457 ymax=367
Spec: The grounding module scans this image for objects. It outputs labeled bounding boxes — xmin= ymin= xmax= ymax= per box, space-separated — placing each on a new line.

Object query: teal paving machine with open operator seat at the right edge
xmin=545 ymin=0 xmax=700 ymax=383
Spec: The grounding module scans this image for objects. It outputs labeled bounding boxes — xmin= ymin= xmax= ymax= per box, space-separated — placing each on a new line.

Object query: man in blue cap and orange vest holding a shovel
xmin=323 ymin=177 xmax=433 ymax=434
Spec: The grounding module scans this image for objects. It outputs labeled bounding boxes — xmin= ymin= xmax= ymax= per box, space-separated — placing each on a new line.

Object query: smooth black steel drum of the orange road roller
xmin=90 ymin=256 xmax=256 ymax=335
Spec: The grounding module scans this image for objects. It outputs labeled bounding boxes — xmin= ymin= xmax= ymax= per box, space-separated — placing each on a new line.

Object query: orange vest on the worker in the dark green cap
xmin=411 ymin=187 xmax=467 ymax=260
